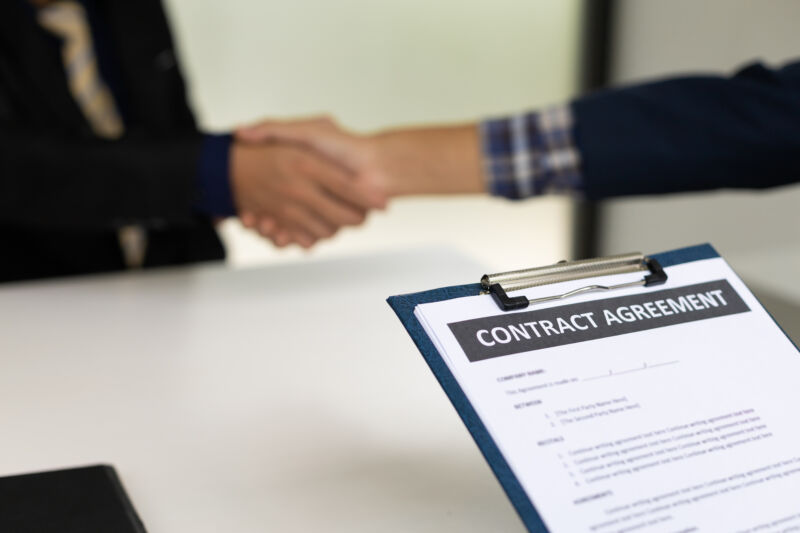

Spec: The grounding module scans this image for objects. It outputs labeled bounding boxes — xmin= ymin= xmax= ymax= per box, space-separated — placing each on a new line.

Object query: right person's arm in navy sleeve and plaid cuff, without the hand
xmin=375 ymin=60 xmax=800 ymax=204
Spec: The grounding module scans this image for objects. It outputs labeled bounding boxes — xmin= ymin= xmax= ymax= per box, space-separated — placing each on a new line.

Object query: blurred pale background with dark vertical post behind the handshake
xmin=159 ymin=0 xmax=800 ymax=334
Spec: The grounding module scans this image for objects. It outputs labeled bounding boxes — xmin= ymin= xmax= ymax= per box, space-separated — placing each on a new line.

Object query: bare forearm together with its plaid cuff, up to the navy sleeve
xmin=372 ymin=104 xmax=583 ymax=199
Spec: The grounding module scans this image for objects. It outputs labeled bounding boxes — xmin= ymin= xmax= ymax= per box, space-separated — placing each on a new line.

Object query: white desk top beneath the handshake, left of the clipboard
xmin=0 ymin=249 xmax=524 ymax=533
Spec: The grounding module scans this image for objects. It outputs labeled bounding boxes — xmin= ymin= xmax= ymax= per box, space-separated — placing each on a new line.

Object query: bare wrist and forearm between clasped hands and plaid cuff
xmin=371 ymin=124 xmax=486 ymax=196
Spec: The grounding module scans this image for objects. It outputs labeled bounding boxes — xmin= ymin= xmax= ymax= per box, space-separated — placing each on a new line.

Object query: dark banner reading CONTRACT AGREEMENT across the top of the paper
xmin=448 ymin=279 xmax=750 ymax=362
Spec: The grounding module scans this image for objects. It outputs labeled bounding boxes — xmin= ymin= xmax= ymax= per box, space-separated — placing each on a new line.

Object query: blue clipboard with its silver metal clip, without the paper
xmin=387 ymin=244 xmax=797 ymax=533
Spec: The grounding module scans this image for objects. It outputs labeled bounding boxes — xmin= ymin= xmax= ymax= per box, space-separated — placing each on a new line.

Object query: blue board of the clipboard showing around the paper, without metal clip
xmin=387 ymin=244 xmax=785 ymax=533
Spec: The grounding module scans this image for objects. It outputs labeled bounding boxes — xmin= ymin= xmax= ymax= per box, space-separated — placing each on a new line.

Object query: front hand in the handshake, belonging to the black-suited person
xmin=231 ymin=142 xmax=386 ymax=248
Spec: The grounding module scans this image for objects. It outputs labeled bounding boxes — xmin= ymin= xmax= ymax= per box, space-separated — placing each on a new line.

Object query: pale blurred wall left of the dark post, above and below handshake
xmin=161 ymin=0 xmax=580 ymax=269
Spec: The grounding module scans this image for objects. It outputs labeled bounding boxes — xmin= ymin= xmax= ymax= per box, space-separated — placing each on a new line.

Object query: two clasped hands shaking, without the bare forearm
xmin=231 ymin=118 xmax=387 ymax=248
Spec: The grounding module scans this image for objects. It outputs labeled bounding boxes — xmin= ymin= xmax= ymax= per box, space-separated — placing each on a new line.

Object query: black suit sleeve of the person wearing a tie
xmin=0 ymin=124 xmax=202 ymax=230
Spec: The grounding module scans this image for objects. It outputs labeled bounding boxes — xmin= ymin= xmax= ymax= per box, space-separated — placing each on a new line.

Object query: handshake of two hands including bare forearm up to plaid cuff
xmin=230 ymin=118 xmax=485 ymax=248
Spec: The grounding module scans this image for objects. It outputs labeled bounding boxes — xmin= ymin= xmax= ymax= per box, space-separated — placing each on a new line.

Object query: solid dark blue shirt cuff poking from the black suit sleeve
xmin=195 ymin=134 xmax=236 ymax=217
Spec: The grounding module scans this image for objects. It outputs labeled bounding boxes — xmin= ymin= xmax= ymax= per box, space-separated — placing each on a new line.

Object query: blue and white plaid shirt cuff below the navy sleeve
xmin=480 ymin=104 xmax=583 ymax=199
